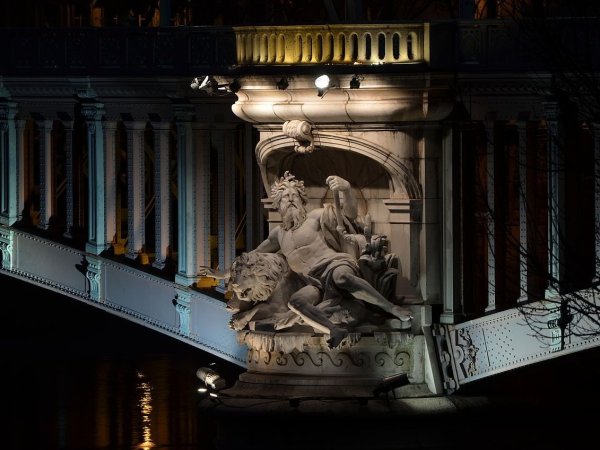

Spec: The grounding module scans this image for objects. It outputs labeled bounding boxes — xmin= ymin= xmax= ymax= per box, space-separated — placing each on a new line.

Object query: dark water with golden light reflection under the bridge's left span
xmin=0 ymin=276 xmax=241 ymax=450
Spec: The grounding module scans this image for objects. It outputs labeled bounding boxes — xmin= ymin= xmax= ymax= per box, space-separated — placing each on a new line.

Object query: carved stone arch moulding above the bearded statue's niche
xmin=256 ymin=133 xmax=422 ymax=199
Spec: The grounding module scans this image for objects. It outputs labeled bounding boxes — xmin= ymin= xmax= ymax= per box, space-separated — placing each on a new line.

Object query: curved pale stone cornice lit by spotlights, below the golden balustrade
xmin=227 ymin=75 xmax=452 ymax=123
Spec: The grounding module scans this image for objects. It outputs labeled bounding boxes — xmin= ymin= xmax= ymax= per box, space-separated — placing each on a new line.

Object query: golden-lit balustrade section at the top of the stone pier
xmin=234 ymin=23 xmax=429 ymax=65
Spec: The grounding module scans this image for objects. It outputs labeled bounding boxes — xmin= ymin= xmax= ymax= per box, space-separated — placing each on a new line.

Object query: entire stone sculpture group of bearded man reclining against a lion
xmin=204 ymin=172 xmax=412 ymax=349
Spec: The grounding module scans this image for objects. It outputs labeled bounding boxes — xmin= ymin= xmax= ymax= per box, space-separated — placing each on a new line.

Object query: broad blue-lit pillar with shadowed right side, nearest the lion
xmin=175 ymin=106 xmax=210 ymax=286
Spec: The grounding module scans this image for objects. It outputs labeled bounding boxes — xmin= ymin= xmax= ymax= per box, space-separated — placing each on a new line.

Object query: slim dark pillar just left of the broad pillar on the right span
xmin=517 ymin=120 xmax=530 ymax=303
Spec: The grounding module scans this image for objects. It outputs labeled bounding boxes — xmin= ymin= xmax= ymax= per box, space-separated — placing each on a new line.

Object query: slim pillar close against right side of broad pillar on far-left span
xmin=104 ymin=120 xmax=117 ymax=247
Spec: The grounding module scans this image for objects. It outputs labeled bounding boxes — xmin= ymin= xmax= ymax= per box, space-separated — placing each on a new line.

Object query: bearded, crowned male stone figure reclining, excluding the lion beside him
xmin=254 ymin=172 xmax=411 ymax=348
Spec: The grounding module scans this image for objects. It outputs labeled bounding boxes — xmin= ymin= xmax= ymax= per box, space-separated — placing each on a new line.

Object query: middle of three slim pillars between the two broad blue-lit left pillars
xmin=125 ymin=121 xmax=146 ymax=259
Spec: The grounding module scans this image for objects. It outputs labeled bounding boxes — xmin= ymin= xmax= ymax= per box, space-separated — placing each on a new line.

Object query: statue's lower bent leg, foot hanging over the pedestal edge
xmin=288 ymin=286 xmax=348 ymax=348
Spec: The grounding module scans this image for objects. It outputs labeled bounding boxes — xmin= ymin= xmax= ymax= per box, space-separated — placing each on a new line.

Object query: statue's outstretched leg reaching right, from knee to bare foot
xmin=332 ymin=266 xmax=412 ymax=321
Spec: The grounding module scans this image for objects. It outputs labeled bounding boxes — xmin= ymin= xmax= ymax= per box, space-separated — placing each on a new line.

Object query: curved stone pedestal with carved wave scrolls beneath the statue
xmin=220 ymin=331 xmax=432 ymax=399
